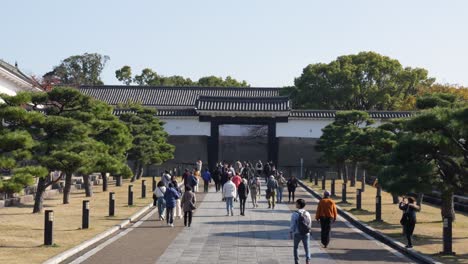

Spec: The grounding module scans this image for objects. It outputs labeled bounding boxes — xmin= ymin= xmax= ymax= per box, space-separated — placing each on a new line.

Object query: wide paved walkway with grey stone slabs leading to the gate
xmin=66 ymin=184 xmax=411 ymax=264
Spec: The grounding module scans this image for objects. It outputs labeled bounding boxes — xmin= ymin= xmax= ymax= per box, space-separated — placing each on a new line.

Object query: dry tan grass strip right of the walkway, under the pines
xmin=306 ymin=180 xmax=468 ymax=263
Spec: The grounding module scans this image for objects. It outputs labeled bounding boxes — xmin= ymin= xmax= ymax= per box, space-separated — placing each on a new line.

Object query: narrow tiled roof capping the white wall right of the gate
xmin=289 ymin=110 xmax=414 ymax=119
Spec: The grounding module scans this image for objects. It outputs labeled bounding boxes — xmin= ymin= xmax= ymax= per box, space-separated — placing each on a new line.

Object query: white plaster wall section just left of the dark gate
xmin=161 ymin=118 xmax=211 ymax=136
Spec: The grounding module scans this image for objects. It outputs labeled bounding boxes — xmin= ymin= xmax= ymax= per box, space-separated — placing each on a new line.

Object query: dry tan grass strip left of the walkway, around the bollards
xmin=0 ymin=175 xmax=165 ymax=263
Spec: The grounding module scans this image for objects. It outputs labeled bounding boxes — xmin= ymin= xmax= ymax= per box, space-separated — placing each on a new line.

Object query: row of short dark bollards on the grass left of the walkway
xmin=44 ymin=179 xmax=150 ymax=246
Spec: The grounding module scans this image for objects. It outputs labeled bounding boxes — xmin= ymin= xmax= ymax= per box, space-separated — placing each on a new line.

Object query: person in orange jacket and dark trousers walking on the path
xmin=315 ymin=191 xmax=337 ymax=248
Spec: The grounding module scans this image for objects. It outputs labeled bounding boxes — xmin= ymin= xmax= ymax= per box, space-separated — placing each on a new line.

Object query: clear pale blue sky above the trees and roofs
xmin=0 ymin=0 xmax=468 ymax=87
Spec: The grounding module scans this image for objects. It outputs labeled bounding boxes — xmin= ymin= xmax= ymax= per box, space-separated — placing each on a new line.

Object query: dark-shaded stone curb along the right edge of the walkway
xmin=298 ymin=180 xmax=441 ymax=264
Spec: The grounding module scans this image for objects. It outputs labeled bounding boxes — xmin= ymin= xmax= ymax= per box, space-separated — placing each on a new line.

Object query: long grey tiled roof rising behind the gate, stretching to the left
xmin=79 ymin=85 xmax=281 ymax=107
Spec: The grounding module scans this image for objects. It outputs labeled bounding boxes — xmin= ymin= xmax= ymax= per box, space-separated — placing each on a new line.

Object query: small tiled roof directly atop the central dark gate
xmin=196 ymin=96 xmax=291 ymax=112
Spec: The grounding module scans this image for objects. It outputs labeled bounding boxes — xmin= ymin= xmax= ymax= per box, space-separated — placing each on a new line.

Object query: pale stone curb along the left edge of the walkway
xmin=43 ymin=202 xmax=153 ymax=264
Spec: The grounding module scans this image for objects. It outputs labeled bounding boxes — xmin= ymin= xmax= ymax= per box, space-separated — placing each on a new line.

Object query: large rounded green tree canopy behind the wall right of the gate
xmin=282 ymin=52 xmax=434 ymax=110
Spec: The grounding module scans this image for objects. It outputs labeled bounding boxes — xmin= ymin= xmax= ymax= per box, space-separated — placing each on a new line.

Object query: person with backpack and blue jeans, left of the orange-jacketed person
xmin=289 ymin=199 xmax=312 ymax=264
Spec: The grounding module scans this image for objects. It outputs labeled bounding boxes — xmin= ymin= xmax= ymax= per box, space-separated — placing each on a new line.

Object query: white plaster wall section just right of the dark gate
xmin=276 ymin=119 xmax=333 ymax=138
